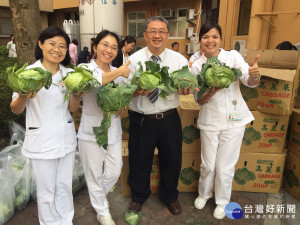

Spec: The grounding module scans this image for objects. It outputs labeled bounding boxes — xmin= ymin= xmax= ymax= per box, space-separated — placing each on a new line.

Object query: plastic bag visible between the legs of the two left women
xmin=72 ymin=152 xmax=85 ymax=194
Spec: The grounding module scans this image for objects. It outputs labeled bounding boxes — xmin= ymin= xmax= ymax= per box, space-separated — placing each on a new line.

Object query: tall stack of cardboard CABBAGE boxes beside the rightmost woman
xmin=233 ymin=50 xmax=299 ymax=193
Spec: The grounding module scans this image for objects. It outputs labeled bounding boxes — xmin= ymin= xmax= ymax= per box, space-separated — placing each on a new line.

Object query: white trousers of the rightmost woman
xmin=198 ymin=126 xmax=245 ymax=206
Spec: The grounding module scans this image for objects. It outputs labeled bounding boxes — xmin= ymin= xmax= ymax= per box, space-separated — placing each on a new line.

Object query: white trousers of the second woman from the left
xmin=78 ymin=139 xmax=123 ymax=216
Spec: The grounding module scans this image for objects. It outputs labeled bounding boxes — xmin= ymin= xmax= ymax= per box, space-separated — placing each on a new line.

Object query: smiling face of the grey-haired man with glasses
xmin=144 ymin=20 xmax=169 ymax=55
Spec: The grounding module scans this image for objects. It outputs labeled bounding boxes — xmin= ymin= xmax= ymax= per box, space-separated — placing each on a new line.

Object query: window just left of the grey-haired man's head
xmin=127 ymin=12 xmax=145 ymax=37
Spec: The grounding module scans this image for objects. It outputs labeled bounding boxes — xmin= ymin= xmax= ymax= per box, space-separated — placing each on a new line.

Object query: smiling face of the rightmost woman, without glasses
xmin=200 ymin=28 xmax=221 ymax=58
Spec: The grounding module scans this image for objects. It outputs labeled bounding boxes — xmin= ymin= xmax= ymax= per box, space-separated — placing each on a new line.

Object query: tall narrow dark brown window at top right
xmin=237 ymin=0 xmax=252 ymax=35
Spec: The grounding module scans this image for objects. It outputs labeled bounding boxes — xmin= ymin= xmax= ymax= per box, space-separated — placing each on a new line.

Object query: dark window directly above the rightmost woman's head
xmin=201 ymin=0 xmax=220 ymax=25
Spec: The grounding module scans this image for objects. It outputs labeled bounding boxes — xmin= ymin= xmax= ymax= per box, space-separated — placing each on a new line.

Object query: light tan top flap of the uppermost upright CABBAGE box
xmin=259 ymin=68 xmax=296 ymax=82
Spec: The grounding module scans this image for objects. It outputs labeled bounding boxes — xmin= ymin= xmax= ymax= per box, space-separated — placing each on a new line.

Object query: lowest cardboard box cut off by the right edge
xmin=284 ymin=153 xmax=300 ymax=201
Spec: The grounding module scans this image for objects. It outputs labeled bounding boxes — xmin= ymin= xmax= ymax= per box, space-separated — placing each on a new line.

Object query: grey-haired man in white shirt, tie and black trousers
xmin=128 ymin=16 xmax=189 ymax=215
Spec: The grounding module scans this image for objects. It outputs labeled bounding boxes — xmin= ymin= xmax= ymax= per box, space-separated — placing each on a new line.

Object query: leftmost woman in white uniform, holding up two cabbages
xmin=10 ymin=27 xmax=80 ymax=225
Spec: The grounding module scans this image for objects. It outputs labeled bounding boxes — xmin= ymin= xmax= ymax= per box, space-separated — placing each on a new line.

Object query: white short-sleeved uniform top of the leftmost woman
xmin=12 ymin=60 xmax=77 ymax=159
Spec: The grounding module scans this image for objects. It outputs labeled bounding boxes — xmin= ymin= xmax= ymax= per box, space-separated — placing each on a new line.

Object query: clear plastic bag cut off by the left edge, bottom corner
xmin=0 ymin=154 xmax=15 ymax=225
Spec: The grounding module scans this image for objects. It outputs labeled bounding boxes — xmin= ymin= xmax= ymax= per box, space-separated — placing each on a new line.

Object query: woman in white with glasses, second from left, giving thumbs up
xmin=77 ymin=30 xmax=130 ymax=225
